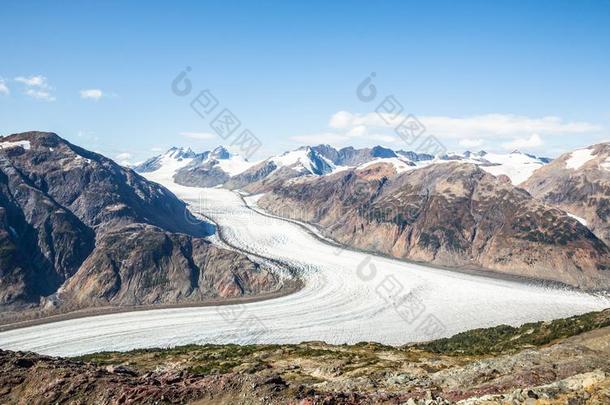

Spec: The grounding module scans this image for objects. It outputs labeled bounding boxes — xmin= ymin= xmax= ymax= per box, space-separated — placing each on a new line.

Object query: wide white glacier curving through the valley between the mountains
xmin=0 ymin=168 xmax=610 ymax=356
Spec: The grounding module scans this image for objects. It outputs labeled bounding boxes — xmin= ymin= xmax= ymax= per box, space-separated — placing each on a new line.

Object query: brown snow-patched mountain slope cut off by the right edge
xmin=521 ymin=143 xmax=610 ymax=245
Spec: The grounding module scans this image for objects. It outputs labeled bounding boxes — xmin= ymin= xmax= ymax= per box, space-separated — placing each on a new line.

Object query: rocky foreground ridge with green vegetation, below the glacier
xmin=0 ymin=310 xmax=610 ymax=404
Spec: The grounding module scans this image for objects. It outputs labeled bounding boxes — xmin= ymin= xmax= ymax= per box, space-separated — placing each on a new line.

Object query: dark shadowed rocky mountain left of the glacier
xmin=0 ymin=132 xmax=276 ymax=308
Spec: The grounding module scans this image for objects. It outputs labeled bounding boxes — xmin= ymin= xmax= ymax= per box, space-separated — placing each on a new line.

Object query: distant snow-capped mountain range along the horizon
xmin=134 ymin=145 xmax=551 ymax=193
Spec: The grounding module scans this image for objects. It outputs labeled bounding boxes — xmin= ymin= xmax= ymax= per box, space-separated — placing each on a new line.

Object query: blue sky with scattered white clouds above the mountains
xmin=0 ymin=0 xmax=610 ymax=161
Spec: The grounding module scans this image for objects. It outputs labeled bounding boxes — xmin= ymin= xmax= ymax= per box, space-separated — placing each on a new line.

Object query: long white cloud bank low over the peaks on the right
xmin=329 ymin=111 xmax=603 ymax=139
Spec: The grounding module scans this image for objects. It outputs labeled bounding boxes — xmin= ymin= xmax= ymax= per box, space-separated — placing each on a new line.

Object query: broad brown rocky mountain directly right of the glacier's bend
xmin=259 ymin=162 xmax=610 ymax=289
